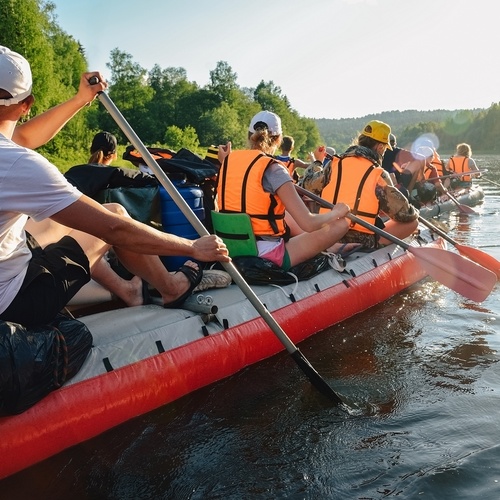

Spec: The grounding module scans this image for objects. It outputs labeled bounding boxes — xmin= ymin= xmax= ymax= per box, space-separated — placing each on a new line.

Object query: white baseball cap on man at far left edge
xmin=0 ymin=45 xmax=33 ymax=106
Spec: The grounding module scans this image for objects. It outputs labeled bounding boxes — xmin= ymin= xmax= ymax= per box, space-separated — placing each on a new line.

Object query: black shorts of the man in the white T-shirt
xmin=0 ymin=236 xmax=90 ymax=326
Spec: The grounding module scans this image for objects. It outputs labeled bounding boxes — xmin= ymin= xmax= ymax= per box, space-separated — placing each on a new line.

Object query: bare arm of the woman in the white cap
xmin=276 ymin=182 xmax=349 ymax=233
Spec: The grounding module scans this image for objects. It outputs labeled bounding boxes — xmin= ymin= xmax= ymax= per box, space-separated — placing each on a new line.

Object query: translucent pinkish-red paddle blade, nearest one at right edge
xmin=408 ymin=247 xmax=497 ymax=302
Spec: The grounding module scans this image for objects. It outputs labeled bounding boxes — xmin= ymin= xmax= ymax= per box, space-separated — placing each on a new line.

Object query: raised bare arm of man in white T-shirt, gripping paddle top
xmin=12 ymin=71 xmax=108 ymax=149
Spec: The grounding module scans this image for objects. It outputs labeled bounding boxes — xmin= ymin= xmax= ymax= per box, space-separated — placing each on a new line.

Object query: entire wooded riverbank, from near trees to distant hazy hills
xmin=0 ymin=0 xmax=500 ymax=171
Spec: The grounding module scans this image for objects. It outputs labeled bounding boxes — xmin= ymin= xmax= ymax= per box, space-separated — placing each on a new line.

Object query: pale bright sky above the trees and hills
xmin=51 ymin=0 xmax=500 ymax=118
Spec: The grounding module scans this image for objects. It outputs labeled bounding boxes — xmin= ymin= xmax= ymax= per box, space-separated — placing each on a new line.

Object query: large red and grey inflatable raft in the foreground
xmin=0 ymin=226 xmax=445 ymax=477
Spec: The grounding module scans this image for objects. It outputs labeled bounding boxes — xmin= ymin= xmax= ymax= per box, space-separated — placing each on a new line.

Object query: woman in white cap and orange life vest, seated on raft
xmin=217 ymin=111 xmax=358 ymax=270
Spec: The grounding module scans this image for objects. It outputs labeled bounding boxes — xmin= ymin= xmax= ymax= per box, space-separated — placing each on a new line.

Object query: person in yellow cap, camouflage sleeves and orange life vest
xmin=302 ymin=120 xmax=418 ymax=248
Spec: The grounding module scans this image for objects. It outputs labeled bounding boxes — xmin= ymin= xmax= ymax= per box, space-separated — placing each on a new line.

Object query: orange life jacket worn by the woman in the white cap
xmin=217 ymin=150 xmax=286 ymax=236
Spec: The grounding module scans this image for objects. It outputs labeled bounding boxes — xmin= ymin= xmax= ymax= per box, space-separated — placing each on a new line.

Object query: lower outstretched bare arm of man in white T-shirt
xmin=51 ymin=195 xmax=230 ymax=262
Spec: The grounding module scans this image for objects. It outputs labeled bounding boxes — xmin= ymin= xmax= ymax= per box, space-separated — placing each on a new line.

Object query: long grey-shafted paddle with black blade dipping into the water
xmin=89 ymin=77 xmax=343 ymax=403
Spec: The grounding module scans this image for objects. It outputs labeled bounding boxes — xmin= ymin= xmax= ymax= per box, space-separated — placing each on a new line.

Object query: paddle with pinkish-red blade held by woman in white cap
xmin=295 ymin=185 xmax=497 ymax=302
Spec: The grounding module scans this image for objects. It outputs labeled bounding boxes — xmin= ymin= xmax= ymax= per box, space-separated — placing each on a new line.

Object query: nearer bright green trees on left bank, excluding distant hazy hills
xmin=0 ymin=0 xmax=321 ymax=170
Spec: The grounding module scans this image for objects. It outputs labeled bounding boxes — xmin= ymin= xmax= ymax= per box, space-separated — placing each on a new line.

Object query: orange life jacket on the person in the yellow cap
xmin=320 ymin=156 xmax=384 ymax=234
